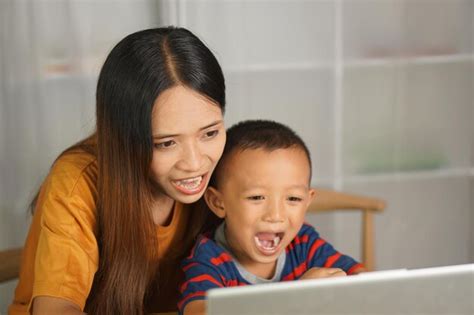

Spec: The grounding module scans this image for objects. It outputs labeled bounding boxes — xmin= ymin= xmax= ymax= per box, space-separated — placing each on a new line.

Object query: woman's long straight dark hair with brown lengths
xmin=65 ymin=27 xmax=225 ymax=315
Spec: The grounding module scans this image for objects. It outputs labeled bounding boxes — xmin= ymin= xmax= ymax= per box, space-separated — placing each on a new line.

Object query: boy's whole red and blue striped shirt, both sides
xmin=178 ymin=224 xmax=362 ymax=314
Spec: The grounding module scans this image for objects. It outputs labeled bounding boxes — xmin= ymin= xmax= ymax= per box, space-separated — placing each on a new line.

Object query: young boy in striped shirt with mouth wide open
xmin=178 ymin=120 xmax=363 ymax=314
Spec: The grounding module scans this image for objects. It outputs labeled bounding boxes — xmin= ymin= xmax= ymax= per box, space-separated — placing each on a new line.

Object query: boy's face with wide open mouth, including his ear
xmin=206 ymin=148 xmax=314 ymax=275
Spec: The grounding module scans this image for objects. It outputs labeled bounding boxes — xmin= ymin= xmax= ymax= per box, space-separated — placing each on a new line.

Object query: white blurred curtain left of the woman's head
xmin=0 ymin=0 xmax=163 ymax=314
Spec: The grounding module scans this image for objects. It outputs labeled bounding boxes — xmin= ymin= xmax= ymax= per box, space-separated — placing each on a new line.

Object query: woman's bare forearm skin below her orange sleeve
xmin=31 ymin=296 xmax=85 ymax=315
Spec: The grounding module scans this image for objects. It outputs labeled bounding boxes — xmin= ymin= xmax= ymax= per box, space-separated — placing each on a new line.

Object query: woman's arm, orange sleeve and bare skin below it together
xmin=25 ymin=154 xmax=99 ymax=314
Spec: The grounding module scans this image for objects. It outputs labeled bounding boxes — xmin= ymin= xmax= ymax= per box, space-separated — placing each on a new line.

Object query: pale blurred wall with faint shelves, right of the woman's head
xmin=177 ymin=0 xmax=474 ymax=269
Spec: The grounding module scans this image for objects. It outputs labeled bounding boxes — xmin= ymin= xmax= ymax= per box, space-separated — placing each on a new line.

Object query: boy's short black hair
xmin=210 ymin=120 xmax=312 ymax=187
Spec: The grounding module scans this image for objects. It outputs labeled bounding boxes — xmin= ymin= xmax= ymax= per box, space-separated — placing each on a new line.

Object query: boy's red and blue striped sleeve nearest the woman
xmin=178 ymin=238 xmax=225 ymax=314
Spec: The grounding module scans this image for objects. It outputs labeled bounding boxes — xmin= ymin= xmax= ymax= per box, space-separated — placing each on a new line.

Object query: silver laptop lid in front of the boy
xmin=207 ymin=264 xmax=474 ymax=315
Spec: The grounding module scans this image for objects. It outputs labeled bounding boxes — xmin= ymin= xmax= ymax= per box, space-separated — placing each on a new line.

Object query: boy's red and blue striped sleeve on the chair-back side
xmin=305 ymin=226 xmax=362 ymax=274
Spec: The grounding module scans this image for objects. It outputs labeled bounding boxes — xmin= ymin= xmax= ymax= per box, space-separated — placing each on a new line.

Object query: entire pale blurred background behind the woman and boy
xmin=0 ymin=0 xmax=474 ymax=313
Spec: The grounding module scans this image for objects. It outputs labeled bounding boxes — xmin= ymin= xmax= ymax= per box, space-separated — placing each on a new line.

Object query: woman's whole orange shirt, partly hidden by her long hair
xmin=9 ymin=151 xmax=189 ymax=315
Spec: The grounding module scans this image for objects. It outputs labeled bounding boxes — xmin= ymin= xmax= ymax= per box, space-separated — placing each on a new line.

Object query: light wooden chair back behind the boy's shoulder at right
xmin=308 ymin=189 xmax=386 ymax=271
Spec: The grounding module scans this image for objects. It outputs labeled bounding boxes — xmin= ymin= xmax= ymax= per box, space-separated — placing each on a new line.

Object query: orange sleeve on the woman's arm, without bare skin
xmin=28 ymin=155 xmax=99 ymax=310
